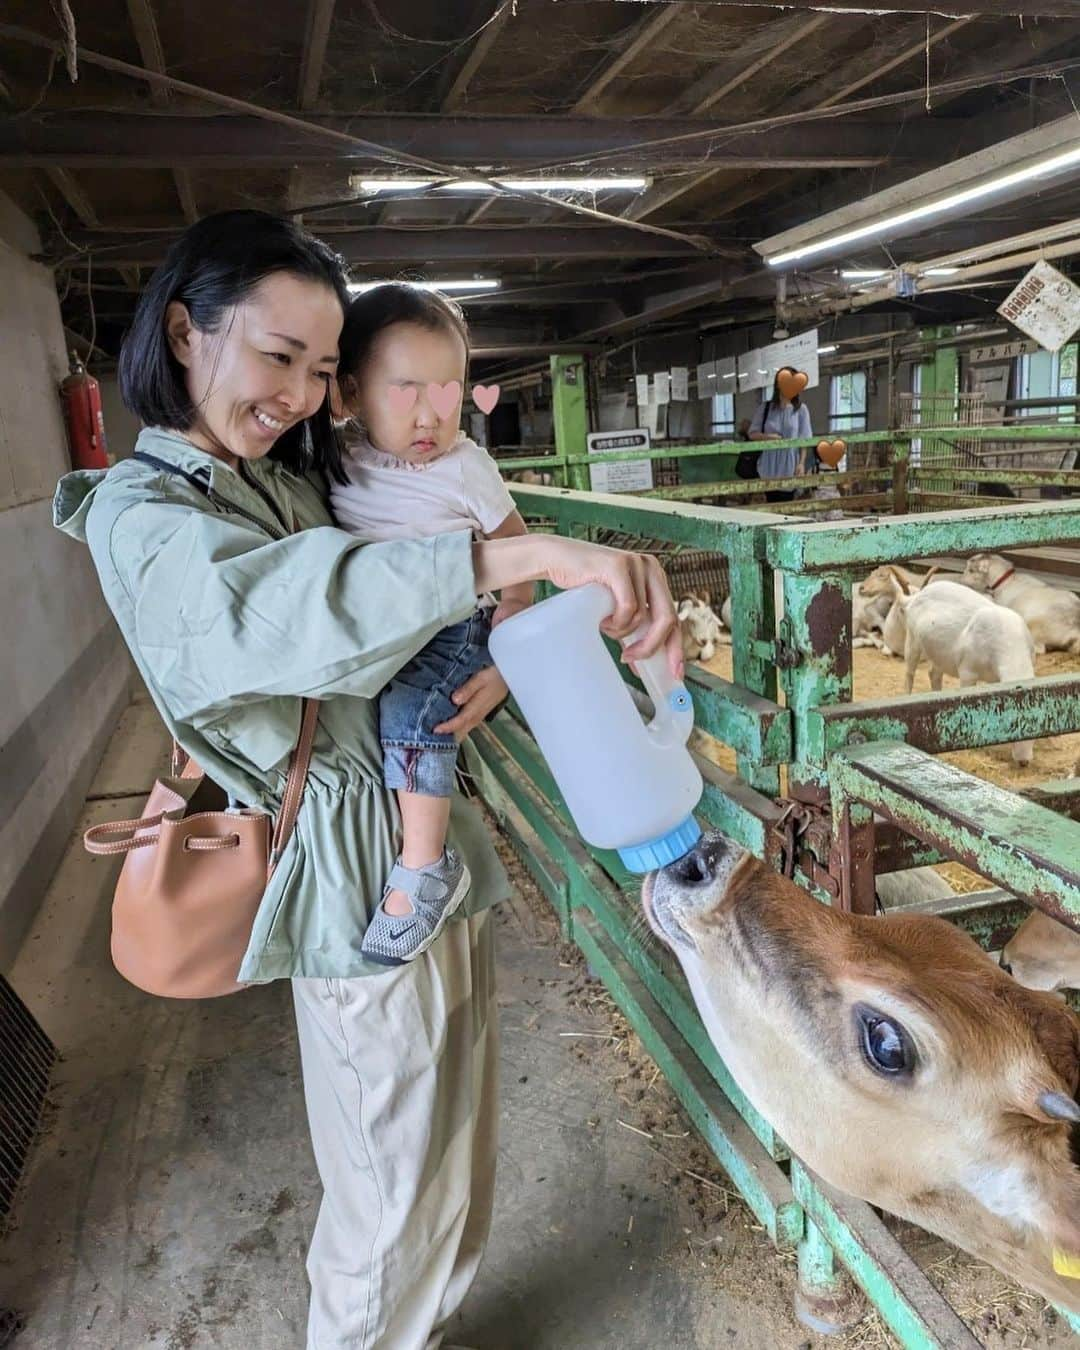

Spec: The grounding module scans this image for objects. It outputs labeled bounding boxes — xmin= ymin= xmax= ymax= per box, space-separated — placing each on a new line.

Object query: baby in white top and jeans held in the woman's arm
xmin=331 ymin=282 xmax=532 ymax=965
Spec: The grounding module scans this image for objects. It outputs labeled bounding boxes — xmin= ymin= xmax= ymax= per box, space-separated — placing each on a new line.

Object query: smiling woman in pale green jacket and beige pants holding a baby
xmin=55 ymin=211 xmax=678 ymax=1350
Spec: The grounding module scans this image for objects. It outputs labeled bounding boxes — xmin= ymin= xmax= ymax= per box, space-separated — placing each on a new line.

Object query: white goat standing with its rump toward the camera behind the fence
xmin=895 ymin=579 xmax=1035 ymax=764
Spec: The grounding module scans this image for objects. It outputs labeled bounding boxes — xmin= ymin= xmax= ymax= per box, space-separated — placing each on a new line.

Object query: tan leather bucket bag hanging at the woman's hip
xmin=84 ymin=699 xmax=319 ymax=999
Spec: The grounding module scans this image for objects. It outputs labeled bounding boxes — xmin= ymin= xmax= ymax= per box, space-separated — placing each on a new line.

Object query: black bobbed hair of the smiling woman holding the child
xmin=119 ymin=211 xmax=348 ymax=482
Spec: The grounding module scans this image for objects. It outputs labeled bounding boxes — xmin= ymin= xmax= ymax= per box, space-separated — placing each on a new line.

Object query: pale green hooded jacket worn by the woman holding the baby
xmin=53 ymin=429 xmax=508 ymax=981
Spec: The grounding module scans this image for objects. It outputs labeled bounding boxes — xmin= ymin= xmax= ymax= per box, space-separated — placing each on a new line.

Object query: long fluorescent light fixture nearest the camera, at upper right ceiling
xmin=755 ymin=115 xmax=1080 ymax=267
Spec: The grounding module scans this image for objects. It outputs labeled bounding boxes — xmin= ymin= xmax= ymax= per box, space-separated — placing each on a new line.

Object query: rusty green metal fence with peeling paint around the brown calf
xmin=466 ymin=480 xmax=1080 ymax=1350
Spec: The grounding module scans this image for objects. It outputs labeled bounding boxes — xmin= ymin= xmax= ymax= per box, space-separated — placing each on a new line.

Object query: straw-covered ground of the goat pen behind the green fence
xmin=691 ymin=647 xmax=1080 ymax=894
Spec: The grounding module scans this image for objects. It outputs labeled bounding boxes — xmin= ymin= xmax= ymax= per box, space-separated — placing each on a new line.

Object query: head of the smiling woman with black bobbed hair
xmin=120 ymin=211 xmax=348 ymax=477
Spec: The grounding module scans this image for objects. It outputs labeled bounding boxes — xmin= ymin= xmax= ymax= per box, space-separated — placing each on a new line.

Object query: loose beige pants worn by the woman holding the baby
xmin=293 ymin=914 xmax=498 ymax=1350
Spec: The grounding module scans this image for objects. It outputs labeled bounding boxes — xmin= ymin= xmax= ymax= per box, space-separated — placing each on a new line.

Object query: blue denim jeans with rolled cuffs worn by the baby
xmin=379 ymin=609 xmax=491 ymax=797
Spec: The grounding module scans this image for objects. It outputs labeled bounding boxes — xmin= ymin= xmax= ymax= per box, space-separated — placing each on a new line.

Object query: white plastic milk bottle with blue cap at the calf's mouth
xmin=490 ymin=583 xmax=703 ymax=872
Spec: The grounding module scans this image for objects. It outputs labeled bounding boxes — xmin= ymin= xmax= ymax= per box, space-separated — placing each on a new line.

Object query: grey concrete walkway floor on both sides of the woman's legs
xmin=0 ymin=702 xmax=806 ymax=1350
